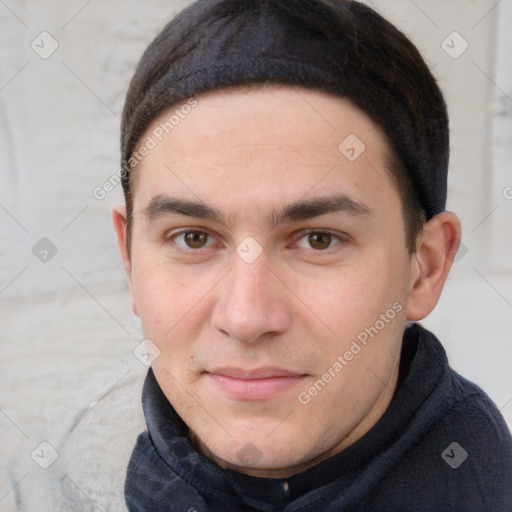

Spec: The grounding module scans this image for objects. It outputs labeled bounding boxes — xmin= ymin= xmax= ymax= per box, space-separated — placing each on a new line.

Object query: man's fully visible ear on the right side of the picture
xmin=407 ymin=212 xmax=461 ymax=321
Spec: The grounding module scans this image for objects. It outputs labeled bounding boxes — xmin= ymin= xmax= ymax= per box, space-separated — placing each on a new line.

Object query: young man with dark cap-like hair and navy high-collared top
xmin=113 ymin=0 xmax=512 ymax=512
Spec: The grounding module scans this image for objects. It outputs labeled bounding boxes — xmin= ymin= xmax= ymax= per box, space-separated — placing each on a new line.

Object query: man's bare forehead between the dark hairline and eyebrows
xmin=133 ymin=86 xmax=399 ymax=216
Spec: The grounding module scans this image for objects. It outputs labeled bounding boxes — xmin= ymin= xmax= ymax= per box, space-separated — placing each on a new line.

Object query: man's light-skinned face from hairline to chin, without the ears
xmin=121 ymin=87 xmax=420 ymax=476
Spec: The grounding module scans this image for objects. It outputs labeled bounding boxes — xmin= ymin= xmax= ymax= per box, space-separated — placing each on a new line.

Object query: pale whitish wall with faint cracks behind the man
xmin=0 ymin=0 xmax=512 ymax=511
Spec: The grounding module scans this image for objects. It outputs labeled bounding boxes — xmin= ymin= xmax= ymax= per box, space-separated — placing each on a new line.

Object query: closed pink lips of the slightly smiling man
xmin=206 ymin=367 xmax=306 ymax=400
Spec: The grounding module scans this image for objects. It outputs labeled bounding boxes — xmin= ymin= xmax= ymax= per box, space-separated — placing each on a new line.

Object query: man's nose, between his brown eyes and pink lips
xmin=212 ymin=255 xmax=292 ymax=343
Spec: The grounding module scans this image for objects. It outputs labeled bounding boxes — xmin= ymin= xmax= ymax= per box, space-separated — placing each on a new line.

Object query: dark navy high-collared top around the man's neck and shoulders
xmin=125 ymin=324 xmax=512 ymax=512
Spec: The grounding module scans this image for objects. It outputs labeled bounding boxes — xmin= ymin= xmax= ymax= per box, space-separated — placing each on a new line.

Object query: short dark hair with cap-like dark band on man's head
xmin=121 ymin=0 xmax=449 ymax=252
